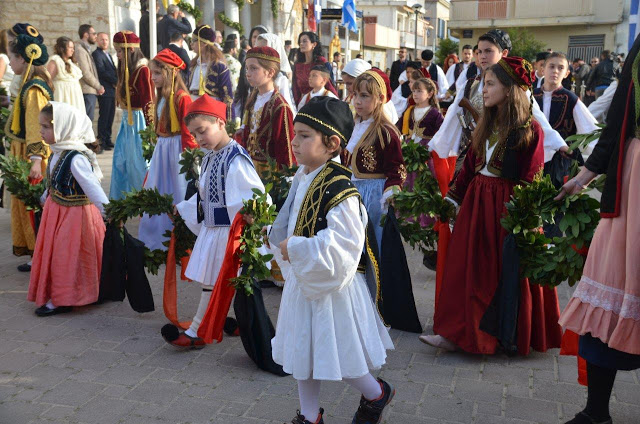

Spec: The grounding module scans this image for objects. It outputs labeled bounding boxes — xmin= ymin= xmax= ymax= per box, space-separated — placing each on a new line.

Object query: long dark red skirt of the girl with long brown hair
xmin=433 ymin=175 xmax=562 ymax=355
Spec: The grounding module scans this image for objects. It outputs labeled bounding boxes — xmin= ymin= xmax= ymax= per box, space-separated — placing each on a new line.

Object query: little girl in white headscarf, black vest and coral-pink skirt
xmin=27 ymin=102 xmax=109 ymax=316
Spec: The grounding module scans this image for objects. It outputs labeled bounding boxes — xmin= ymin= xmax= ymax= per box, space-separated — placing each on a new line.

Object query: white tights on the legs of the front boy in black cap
xmin=298 ymin=373 xmax=382 ymax=422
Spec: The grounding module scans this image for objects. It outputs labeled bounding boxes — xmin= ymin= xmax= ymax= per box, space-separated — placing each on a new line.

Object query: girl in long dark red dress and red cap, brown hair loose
xmin=420 ymin=57 xmax=561 ymax=355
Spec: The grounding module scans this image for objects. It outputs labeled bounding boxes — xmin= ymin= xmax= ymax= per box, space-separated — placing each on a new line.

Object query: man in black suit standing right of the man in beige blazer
xmin=91 ymin=32 xmax=118 ymax=150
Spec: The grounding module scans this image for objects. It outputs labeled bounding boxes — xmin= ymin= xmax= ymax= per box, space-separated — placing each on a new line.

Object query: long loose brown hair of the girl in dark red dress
xmin=472 ymin=64 xmax=533 ymax=155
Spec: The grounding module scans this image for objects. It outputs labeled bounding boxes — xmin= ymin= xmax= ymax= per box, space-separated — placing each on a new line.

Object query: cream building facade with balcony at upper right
xmin=449 ymin=0 xmax=628 ymax=59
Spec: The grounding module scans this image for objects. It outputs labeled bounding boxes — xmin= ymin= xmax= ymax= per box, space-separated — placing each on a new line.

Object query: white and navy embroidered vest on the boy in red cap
xmin=197 ymin=140 xmax=253 ymax=227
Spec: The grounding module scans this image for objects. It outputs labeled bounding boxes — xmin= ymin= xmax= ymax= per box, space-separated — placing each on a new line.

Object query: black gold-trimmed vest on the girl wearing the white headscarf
xmin=47 ymin=150 xmax=91 ymax=206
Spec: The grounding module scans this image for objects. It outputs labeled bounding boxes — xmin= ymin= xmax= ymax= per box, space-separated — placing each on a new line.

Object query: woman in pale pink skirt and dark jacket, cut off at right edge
xmin=558 ymin=37 xmax=640 ymax=424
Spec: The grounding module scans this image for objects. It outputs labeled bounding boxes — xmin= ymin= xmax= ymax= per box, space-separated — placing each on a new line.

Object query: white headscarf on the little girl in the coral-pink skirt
xmin=49 ymin=102 xmax=102 ymax=179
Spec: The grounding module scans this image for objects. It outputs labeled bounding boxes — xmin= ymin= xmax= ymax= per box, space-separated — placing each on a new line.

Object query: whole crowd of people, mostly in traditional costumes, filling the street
xmin=0 ymin=5 xmax=640 ymax=424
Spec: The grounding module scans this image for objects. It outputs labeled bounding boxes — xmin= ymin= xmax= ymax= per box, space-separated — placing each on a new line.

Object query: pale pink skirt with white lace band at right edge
xmin=559 ymin=138 xmax=640 ymax=355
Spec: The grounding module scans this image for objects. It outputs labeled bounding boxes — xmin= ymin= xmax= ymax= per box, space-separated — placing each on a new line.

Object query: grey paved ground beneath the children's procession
xmin=0 ymin=153 xmax=640 ymax=424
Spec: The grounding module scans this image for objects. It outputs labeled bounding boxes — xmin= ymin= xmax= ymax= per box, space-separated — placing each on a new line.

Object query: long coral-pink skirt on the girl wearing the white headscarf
xmin=27 ymin=197 xmax=105 ymax=306
